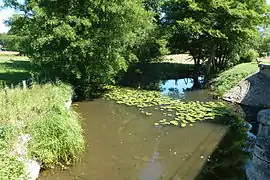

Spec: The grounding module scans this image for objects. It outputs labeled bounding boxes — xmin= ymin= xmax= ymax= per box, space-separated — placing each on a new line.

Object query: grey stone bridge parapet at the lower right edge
xmin=246 ymin=109 xmax=270 ymax=180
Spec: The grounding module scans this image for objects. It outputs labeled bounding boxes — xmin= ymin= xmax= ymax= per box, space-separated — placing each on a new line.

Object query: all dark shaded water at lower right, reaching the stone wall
xmin=196 ymin=104 xmax=265 ymax=180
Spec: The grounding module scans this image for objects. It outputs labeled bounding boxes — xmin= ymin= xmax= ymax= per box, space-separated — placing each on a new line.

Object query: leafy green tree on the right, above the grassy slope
xmin=162 ymin=0 xmax=269 ymax=73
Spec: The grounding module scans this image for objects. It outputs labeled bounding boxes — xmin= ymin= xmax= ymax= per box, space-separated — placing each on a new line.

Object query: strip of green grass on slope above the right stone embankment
xmin=210 ymin=62 xmax=258 ymax=97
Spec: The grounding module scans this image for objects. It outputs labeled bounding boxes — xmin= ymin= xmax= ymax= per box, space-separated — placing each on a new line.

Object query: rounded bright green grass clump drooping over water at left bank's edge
xmin=27 ymin=109 xmax=84 ymax=167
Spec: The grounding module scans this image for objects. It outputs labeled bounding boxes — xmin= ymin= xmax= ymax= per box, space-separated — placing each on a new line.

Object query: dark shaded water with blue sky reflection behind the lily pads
xmin=118 ymin=63 xmax=213 ymax=101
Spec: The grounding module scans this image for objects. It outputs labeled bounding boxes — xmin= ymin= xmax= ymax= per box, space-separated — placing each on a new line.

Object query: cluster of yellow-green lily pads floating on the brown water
xmin=104 ymin=86 xmax=231 ymax=127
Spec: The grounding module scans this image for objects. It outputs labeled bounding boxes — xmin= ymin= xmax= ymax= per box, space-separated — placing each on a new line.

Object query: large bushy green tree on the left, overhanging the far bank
xmin=5 ymin=0 xmax=154 ymax=96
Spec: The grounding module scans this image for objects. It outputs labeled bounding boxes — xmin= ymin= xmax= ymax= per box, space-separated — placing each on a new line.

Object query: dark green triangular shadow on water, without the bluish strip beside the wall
xmin=195 ymin=119 xmax=251 ymax=180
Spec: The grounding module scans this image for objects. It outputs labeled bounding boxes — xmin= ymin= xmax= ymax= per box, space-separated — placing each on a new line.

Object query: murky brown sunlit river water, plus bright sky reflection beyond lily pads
xmin=39 ymin=79 xmax=248 ymax=180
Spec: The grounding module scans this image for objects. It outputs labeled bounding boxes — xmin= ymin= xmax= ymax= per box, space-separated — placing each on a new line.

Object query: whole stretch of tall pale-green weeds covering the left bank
xmin=0 ymin=84 xmax=84 ymax=180
